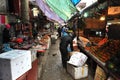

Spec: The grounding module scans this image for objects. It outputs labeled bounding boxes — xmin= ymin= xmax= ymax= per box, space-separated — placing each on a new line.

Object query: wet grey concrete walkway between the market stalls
xmin=40 ymin=39 xmax=93 ymax=80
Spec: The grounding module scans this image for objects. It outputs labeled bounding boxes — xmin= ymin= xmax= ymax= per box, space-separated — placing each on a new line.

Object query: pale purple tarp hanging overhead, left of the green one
xmin=36 ymin=0 xmax=64 ymax=24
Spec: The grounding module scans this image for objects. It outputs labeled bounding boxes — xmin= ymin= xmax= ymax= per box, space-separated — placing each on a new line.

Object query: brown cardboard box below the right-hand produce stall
xmin=94 ymin=66 xmax=106 ymax=80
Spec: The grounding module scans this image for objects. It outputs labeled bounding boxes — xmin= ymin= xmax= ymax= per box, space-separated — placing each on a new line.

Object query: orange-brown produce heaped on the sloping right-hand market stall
xmin=86 ymin=38 xmax=120 ymax=62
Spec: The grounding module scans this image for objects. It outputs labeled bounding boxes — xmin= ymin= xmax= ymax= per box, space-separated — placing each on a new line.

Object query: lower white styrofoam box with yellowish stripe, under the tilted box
xmin=67 ymin=63 xmax=88 ymax=79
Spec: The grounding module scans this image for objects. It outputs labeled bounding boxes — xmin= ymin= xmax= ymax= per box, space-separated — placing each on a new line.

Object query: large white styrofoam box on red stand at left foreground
xmin=0 ymin=50 xmax=32 ymax=80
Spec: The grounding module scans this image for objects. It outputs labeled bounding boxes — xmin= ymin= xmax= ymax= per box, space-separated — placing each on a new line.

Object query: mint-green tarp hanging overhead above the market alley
xmin=45 ymin=0 xmax=76 ymax=21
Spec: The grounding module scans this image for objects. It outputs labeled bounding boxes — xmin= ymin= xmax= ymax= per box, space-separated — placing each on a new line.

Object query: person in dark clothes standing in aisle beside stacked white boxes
xmin=60 ymin=25 xmax=74 ymax=69
